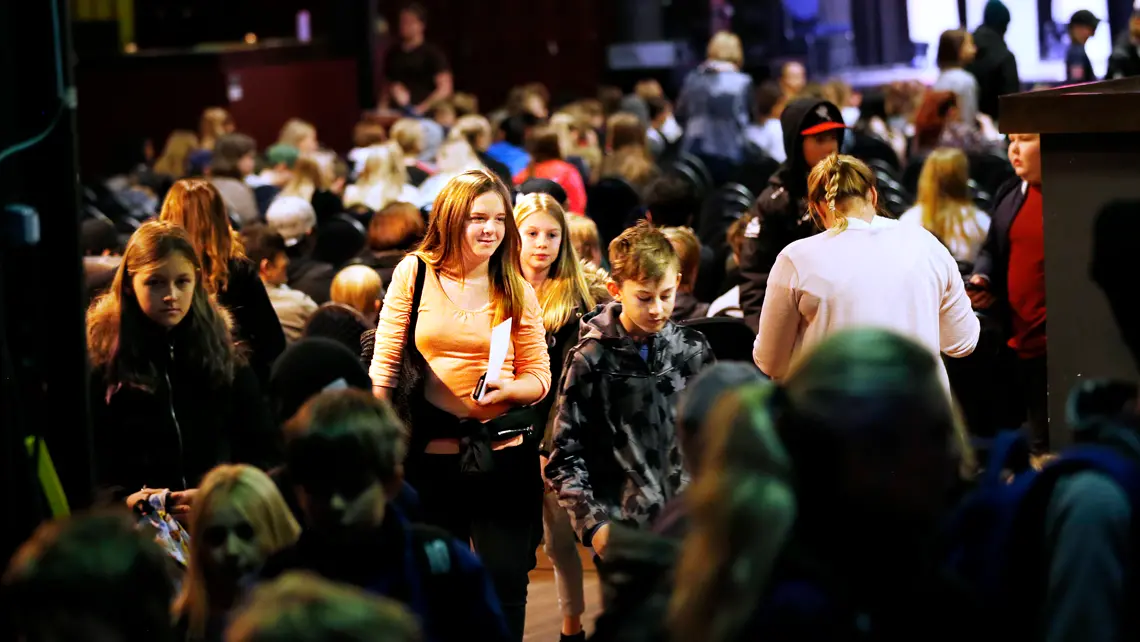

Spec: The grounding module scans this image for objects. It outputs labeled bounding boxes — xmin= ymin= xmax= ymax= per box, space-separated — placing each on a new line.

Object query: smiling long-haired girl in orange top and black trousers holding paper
xmin=369 ymin=170 xmax=551 ymax=640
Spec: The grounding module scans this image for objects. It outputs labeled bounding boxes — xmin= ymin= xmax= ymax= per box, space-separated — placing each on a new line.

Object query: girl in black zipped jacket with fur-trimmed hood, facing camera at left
xmin=87 ymin=221 xmax=280 ymax=505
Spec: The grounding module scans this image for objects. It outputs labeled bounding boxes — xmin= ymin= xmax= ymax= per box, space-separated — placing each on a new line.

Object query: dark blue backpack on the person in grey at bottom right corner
xmin=947 ymin=431 xmax=1140 ymax=640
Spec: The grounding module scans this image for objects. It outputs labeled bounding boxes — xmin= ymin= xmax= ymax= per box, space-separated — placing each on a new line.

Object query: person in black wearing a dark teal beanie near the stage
xmin=966 ymin=0 xmax=1021 ymax=121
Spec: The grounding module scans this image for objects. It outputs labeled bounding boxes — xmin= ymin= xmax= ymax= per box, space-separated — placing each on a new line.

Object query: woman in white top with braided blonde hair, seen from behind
xmin=752 ymin=155 xmax=979 ymax=390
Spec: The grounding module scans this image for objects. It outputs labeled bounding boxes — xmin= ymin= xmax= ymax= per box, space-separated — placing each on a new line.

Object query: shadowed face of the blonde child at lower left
xmin=201 ymin=502 xmax=266 ymax=585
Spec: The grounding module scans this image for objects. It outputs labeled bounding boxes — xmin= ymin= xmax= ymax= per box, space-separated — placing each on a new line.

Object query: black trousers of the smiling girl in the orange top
xmin=405 ymin=442 xmax=543 ymax=641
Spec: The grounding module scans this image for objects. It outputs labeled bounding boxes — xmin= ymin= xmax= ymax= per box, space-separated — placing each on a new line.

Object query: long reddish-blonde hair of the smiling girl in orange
xmin=415 ymin=168 xmax=528 ymax=333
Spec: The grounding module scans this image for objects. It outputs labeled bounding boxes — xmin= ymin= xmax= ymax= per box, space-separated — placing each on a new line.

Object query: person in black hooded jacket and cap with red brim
xmin=740 ymin=98 xmax=846 ymax=328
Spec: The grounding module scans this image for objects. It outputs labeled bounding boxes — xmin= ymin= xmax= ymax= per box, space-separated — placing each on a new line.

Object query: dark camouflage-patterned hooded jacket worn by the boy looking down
xmin=546 ymin=302 xmax=715 ymax=545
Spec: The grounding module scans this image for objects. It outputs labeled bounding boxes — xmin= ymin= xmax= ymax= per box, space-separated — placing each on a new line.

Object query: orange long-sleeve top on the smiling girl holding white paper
xmin=368 ymin=255 xmax=551 ymax=421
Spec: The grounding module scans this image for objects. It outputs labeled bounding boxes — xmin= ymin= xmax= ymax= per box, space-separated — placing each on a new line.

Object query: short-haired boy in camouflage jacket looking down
xmin=546 ymin=221 xmax=715 ymax=558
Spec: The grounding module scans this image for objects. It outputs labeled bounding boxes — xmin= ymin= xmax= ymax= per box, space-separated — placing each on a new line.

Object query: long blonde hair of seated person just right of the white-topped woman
xmin=918 ymin=147 xmax=985 ymax=254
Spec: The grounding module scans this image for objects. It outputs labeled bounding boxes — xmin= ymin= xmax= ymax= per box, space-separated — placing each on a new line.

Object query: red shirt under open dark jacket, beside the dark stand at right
xmin=1007 ymin=185 xmax=1045 ymax=359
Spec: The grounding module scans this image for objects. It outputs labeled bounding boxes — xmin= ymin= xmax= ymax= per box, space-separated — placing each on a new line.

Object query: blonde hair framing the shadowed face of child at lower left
xmin=174 ymin=464 xmax=301 ymax=639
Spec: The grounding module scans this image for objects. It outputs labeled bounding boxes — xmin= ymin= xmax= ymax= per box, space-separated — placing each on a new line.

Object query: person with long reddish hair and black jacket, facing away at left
xmin=158 ymin=179 xmax=285 ymax=385
